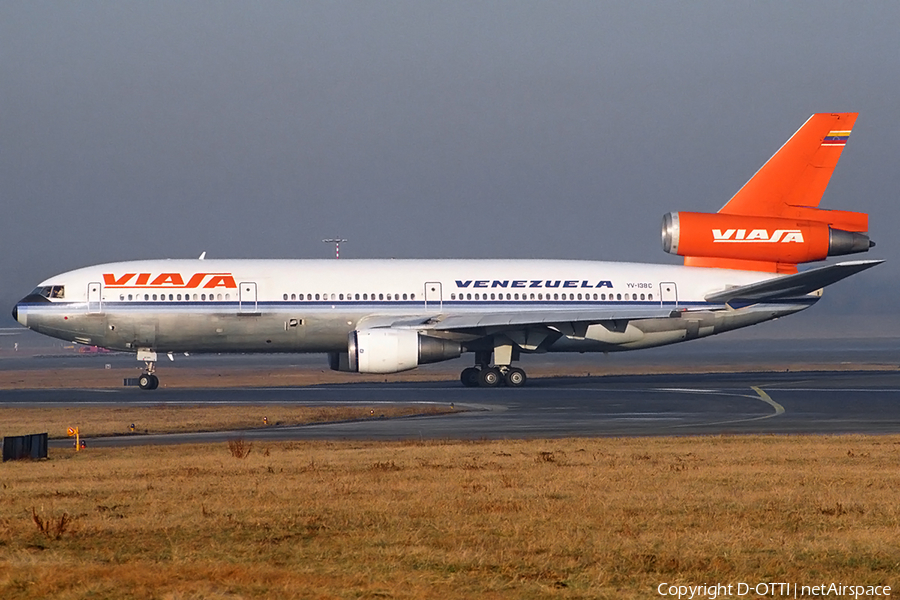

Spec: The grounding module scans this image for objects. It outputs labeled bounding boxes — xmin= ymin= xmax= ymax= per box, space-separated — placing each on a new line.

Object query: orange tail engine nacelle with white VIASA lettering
xmin=662 ymin=212 xmax=875 ymax=265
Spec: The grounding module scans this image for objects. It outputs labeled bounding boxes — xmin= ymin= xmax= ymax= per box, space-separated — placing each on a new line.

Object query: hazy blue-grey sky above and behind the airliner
xmin=0 ymin=0 xmax=900 ymax=325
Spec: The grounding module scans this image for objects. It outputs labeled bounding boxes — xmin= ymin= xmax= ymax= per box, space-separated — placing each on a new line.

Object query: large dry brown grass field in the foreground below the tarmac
xmin=0 ymin=436 xmax=900 ymax=600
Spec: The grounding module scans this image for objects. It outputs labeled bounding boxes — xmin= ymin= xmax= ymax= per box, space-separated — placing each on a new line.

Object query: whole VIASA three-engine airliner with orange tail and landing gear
xmin=12 ymin=113 xmax=883 ymax=390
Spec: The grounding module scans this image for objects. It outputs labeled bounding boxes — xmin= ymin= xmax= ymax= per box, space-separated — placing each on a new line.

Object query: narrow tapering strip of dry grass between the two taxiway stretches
xmin=0 ymin=404 xmax=454 ymax=439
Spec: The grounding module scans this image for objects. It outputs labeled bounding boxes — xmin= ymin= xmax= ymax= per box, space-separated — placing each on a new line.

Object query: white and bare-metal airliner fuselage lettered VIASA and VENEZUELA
xmin=16 ymin=259 xmax=819 ymax=353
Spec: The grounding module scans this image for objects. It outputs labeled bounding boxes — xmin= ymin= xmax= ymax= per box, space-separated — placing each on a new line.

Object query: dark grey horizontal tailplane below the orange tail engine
xmin=705 ymin=260 xmax=884 ymax=305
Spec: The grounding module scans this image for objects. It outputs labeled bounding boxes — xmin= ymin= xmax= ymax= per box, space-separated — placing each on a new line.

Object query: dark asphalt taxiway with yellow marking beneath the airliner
xmin=0 ymin=371 xmax=900 ymax=446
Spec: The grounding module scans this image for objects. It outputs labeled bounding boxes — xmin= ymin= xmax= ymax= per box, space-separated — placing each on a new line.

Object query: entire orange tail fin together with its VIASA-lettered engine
xmin=662 ymin=113 xmax=875 ymax=273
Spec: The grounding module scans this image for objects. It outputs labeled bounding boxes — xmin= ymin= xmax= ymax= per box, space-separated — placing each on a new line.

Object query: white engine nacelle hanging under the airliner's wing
xmin=329 ymin=328 xmax=462 ymax=373
